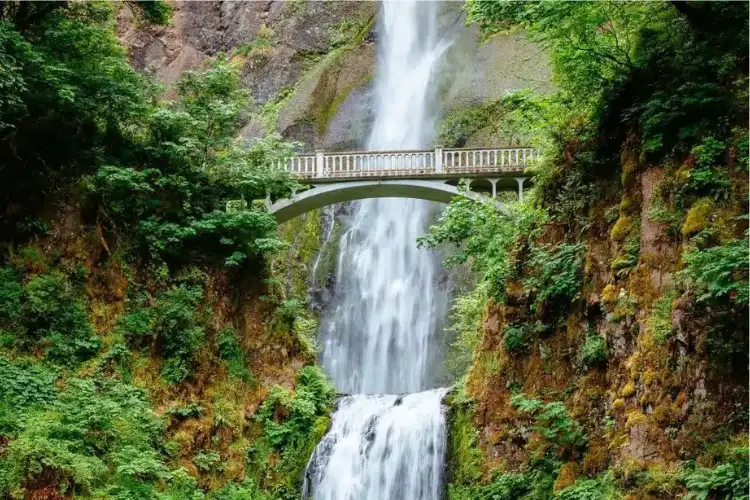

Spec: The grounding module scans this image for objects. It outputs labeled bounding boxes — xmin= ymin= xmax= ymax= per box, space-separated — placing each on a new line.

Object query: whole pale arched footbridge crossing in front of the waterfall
xmin=266 ymin=146 xmax=536 ymax=223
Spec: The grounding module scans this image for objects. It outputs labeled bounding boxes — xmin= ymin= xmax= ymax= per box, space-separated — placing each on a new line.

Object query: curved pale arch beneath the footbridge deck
xmin=268 ymin=179 xmax=500 ymax=223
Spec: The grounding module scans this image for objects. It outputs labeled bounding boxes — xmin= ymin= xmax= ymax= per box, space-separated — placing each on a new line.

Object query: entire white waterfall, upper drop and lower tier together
xmin=303 ymin=0 xmax=448 ymax=500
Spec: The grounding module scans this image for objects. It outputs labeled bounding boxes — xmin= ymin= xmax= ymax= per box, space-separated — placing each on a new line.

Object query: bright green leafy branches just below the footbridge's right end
xmin=419 ymin=193 xmax=544 ymax=300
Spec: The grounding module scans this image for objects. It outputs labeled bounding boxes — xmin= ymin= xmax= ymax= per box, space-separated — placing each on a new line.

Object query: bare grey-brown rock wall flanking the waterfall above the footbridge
xmin=117 ymin=0 xmax=550 ymax=150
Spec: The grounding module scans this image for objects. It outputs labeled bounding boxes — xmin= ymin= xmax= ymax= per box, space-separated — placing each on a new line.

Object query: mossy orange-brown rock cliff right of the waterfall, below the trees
xmin=449 ymin=139 xmax=748 ymax=499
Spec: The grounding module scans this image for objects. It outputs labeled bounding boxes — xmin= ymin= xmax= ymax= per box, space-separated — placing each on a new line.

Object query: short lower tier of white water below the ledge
xmin=303 ymin=389 xmax=446 ymax=500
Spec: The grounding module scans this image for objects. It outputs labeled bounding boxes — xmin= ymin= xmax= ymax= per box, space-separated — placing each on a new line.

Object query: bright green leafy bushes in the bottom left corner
xmin=0 ymin=379 xmax=184 ymax=499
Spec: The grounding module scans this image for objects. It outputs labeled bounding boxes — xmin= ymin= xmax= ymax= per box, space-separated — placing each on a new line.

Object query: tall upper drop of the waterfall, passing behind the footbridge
xmin=320 ymin=1 xmax=447 ymax=393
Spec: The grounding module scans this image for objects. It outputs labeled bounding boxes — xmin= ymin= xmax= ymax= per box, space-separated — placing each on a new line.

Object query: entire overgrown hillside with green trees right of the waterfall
xmin=444 ymin=0 xmax=748 ymax=499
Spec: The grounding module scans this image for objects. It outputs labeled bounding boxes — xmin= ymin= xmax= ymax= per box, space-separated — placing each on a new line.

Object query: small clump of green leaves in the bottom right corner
xmin=685 ymin=446 xmax=750 ymax=500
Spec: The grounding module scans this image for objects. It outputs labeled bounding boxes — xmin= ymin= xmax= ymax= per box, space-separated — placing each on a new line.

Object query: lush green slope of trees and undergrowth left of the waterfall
xmin=0 ymin=1 xmax=333 ymax=500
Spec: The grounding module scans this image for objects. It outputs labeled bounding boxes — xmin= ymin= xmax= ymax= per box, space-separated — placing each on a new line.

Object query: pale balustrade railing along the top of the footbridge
xmin=282 ymin=146 xmax=536 ymax=179
